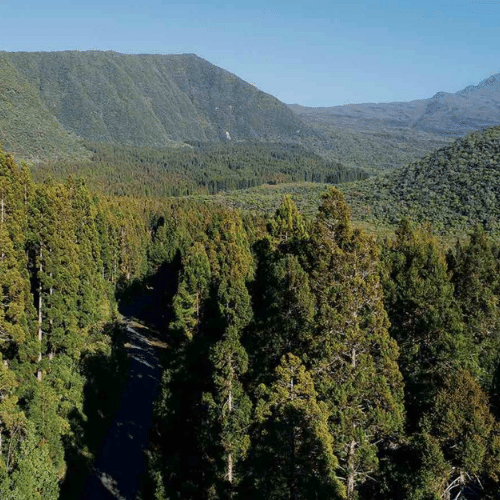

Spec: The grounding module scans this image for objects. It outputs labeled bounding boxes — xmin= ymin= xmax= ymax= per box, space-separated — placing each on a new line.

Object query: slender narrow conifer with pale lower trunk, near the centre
xmin=204 ymin=213 xmax=252 ymax=496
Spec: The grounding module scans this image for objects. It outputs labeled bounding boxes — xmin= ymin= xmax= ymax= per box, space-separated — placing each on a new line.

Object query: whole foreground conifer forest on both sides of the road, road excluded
xmin=0 ymin=145 xmax=500 ymax=500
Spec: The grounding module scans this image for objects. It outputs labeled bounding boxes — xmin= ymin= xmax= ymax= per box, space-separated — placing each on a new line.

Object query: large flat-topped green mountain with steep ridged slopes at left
xmin=0 ymin=51 xmax=305 ymax=160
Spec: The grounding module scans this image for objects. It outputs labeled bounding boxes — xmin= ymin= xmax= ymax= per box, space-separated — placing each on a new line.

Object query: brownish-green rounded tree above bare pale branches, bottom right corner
xmin=412 ymin=370 xmax=500 ymax=499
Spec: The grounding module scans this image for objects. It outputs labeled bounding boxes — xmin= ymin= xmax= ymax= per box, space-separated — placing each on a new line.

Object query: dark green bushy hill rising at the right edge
xmin=343 ymin=126 xmax=500 ymax=231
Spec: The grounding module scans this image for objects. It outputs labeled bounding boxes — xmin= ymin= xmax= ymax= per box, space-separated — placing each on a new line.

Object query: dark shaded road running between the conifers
xmin=81 ymin=319 xmax=166 ymax=500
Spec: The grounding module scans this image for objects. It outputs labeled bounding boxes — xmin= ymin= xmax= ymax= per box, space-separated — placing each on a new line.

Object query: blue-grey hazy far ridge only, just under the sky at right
xmin=290 ymin=73 xmax=500 ymax=137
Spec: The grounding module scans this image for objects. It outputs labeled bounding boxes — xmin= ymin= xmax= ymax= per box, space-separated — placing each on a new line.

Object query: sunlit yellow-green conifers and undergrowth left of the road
xmin=0 ymin=146 xmax=161 ymax=499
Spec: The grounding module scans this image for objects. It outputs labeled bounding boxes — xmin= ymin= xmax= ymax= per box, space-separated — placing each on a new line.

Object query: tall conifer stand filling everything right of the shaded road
xmin=143 ymin=189 xmax=500 ymax=499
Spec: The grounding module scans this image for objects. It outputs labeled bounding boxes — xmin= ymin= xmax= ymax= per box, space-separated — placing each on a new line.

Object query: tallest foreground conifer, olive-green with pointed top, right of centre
xmin=306 ymin=188 xmax=404 ymax=500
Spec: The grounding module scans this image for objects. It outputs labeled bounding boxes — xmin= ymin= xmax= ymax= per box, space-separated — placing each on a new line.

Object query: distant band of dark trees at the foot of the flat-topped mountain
xmin=34 ymin=142 xmax=369 ymax=197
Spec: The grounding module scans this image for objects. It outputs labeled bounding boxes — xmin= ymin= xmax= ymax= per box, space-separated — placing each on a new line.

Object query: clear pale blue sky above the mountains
xmin=0 ymin=0 xmax=500 ymax=106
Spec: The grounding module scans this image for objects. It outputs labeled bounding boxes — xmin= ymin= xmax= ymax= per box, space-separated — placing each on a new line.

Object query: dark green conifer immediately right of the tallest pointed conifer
xmin=382 ymin=220 xmax=466 ymax=431
